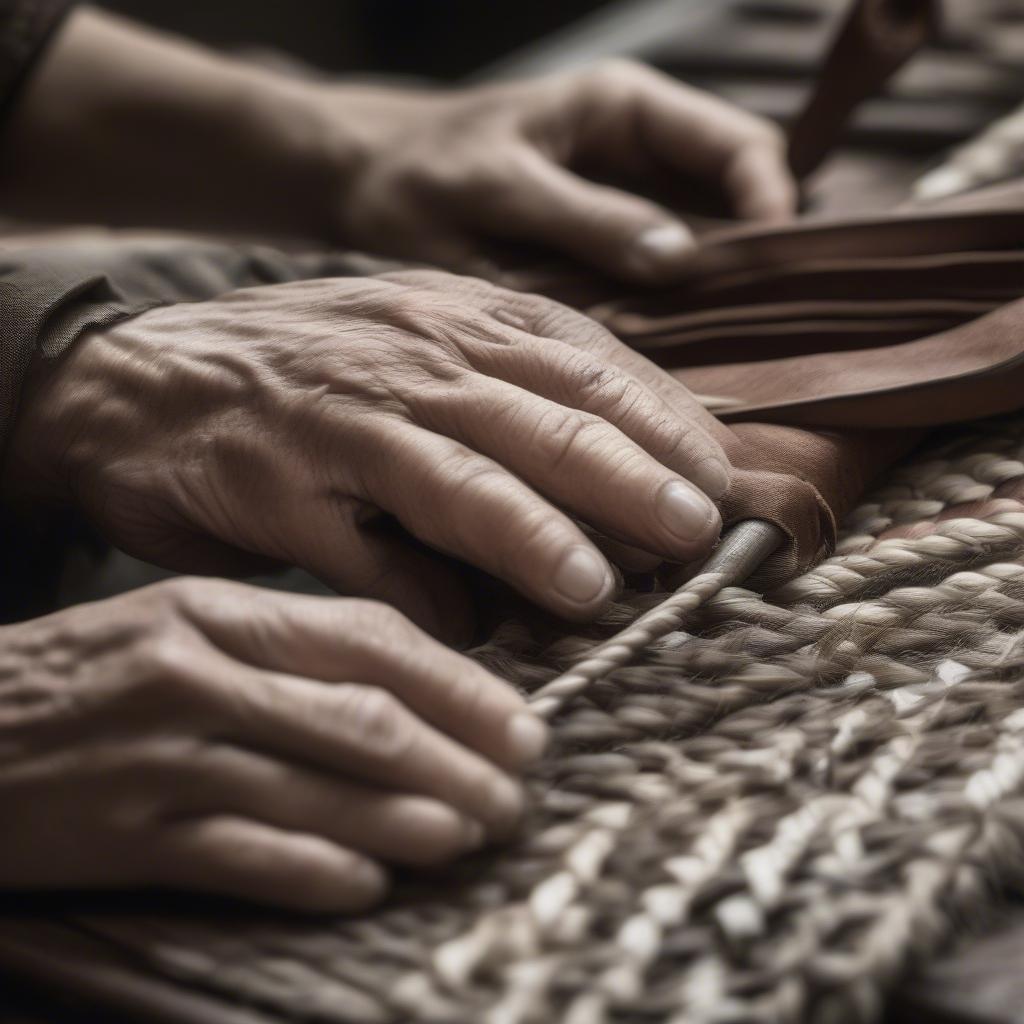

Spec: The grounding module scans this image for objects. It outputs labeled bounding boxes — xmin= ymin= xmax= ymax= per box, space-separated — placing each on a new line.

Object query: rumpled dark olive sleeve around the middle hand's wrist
xmin=0 ymin=232 xmax=390 ymax=449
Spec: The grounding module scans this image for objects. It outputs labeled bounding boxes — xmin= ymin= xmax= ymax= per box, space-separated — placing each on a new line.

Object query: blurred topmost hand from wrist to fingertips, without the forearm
xmin=310 ymin=61 xmax=797 ymax=284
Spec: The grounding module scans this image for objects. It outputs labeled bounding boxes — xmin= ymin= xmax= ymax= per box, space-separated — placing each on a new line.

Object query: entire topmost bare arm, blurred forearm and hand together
xmin=0 ymin=6 xmax=796 ymax=284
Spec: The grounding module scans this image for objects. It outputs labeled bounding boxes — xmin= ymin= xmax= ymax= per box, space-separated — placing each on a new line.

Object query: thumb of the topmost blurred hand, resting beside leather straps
xmin=485 ymin=151 xmax=695 ymax=285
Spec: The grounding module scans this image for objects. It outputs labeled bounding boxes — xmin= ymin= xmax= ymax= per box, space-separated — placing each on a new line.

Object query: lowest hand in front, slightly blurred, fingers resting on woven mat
xmin=0 ymin=579 xmax=545 ymax=911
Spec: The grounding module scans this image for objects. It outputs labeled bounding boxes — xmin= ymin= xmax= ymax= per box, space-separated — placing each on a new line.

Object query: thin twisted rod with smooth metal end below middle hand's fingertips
xmin=529 ymin=519 xmax=785 ymax=719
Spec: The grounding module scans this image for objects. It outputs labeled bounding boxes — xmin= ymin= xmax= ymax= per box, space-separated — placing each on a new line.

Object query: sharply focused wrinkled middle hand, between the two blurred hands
xmin=4 ymin=271 xmax=729 ymax=636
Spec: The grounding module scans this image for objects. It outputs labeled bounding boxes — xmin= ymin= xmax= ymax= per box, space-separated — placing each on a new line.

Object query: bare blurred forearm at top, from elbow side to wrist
xmin=0 ymin=7 xmax=338 ymax=237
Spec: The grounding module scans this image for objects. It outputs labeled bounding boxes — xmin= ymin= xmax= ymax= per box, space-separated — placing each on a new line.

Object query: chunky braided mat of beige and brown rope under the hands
xmin=9 ymin=411 xmax=1024 ymax=1024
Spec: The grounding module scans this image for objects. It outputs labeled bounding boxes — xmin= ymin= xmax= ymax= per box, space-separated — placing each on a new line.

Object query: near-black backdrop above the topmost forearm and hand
xmin=101 ymin=0 xmax=607 ymax=80
